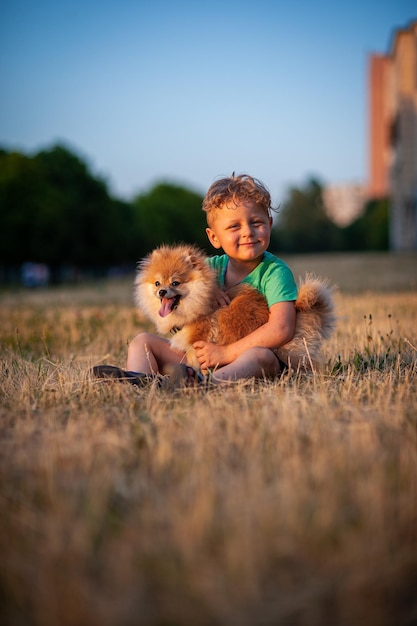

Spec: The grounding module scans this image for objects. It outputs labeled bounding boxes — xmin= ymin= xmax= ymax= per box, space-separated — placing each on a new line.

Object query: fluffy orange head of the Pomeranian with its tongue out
xmin=135 ymin=246 xmax=215 ymax=333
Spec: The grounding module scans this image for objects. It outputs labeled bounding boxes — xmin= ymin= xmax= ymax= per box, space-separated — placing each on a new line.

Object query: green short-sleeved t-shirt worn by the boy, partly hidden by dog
xmin=208 ymin=252 xmax=297 ymax=307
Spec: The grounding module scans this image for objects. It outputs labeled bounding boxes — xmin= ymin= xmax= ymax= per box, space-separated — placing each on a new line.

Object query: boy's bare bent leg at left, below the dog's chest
xmin=126 ymin=333 xmax=185 ymax=374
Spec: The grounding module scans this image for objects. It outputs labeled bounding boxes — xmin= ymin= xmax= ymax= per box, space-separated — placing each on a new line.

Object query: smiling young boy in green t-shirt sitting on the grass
xmin=94 ymin=174 xmax=297 ymax=383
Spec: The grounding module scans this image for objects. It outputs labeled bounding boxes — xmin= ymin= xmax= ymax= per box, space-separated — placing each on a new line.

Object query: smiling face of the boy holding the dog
xmin=206 ymin=203 xmax=272 ymax=261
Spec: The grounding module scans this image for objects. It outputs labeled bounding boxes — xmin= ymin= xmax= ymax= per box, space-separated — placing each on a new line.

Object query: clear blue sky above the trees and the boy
xmin=0 ymin=0 xmax=417 ymax=203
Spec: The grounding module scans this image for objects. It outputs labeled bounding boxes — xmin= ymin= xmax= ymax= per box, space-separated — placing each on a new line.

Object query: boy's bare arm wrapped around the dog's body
xmin=193 ymin=302 xmax=296 ymax=369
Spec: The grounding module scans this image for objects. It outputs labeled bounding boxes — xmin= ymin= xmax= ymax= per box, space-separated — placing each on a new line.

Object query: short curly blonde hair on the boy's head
xmin=203 ymin=172 xmax=273 ymax=226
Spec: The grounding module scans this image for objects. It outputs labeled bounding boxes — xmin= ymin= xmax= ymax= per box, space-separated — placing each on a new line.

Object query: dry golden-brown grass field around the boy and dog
xmin=0 ymin=257 xmax=417 ymax=626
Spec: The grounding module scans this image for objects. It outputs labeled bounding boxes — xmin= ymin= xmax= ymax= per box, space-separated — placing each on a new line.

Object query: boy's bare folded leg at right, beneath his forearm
xmin=213 ymin=348 xmax=281 ymax=383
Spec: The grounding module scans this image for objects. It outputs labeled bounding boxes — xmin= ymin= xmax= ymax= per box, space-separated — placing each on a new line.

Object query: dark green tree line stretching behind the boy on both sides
xmin=0 ymin=145 xmax=388 ymax=279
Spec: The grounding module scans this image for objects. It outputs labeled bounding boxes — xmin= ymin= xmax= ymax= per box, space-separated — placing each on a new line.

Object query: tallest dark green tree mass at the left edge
xmin=0 ymin=146 xmax=136 ymax=268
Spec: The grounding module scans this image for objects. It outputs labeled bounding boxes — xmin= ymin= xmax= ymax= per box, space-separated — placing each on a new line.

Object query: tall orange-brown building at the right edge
xmin=368 ymin=21 xmax=417 ymax=251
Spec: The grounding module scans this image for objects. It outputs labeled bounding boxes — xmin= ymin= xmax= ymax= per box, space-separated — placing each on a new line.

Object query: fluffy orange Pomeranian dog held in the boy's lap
xmin=135 ymin=245 xmax=335 ymax=369
